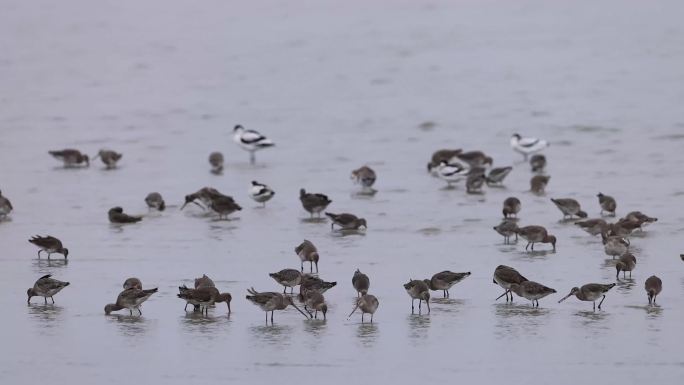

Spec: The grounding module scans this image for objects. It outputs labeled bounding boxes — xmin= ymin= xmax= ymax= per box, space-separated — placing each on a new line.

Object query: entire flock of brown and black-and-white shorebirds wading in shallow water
xmin=0 ymin=125 xmax=672 ymax=323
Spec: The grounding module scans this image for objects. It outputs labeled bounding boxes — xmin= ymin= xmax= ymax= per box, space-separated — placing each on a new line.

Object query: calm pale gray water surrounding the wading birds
xmin=0 ymin=0 xmax=684 ymax=384
